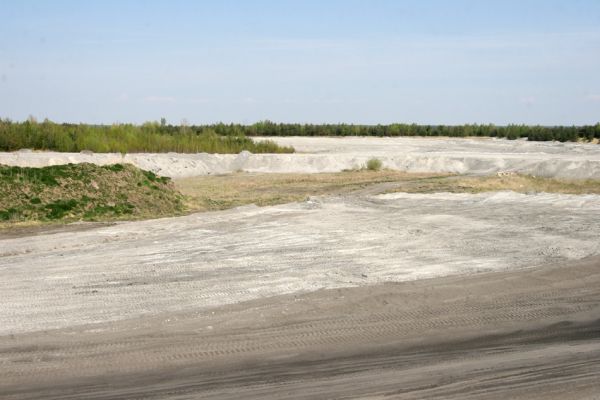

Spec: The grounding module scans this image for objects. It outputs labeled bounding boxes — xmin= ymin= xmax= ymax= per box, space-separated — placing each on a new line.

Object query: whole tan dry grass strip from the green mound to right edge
xmin=174 ymin=169 xmax=600 ymax=211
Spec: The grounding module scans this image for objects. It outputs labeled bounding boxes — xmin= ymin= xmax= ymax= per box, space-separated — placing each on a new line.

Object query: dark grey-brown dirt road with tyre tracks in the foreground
xmin=0 ymin=257 xmax=600 ymax=399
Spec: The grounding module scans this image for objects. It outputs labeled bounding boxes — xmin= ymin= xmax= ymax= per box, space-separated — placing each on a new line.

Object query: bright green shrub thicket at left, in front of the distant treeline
xmin=0 ymin=119 xmax=294 ymax=153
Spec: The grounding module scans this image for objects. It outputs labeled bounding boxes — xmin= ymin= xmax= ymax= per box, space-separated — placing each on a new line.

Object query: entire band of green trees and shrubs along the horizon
xmin=0 ymin=118 xmax=600 ymax=153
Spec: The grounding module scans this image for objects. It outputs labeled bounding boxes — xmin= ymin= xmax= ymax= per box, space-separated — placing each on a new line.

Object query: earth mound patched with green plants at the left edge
xmin=0 ymin=164 xmax=184 ymax=225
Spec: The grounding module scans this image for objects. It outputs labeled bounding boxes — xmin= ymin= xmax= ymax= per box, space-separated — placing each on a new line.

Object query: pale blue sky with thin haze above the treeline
xmin=0 ymin=0 xmax=600 ymax=125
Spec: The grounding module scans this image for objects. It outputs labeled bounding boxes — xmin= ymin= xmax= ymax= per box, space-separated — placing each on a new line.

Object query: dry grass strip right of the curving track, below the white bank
xmin=388 ymin=175 xmax=600 ymax=194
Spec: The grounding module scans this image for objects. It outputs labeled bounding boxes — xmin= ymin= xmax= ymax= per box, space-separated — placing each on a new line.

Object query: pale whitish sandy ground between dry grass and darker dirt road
xmin=0 ymin=192 xmax=600 ymax=335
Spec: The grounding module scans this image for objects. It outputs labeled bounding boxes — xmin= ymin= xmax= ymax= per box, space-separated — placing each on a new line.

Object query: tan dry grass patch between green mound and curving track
xmin=174 ymin=170 xmax=439 ymax=211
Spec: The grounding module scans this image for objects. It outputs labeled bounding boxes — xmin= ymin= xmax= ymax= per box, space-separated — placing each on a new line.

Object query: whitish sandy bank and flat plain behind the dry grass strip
xmin=0 ymin=137 xmax=600 ymax=179
